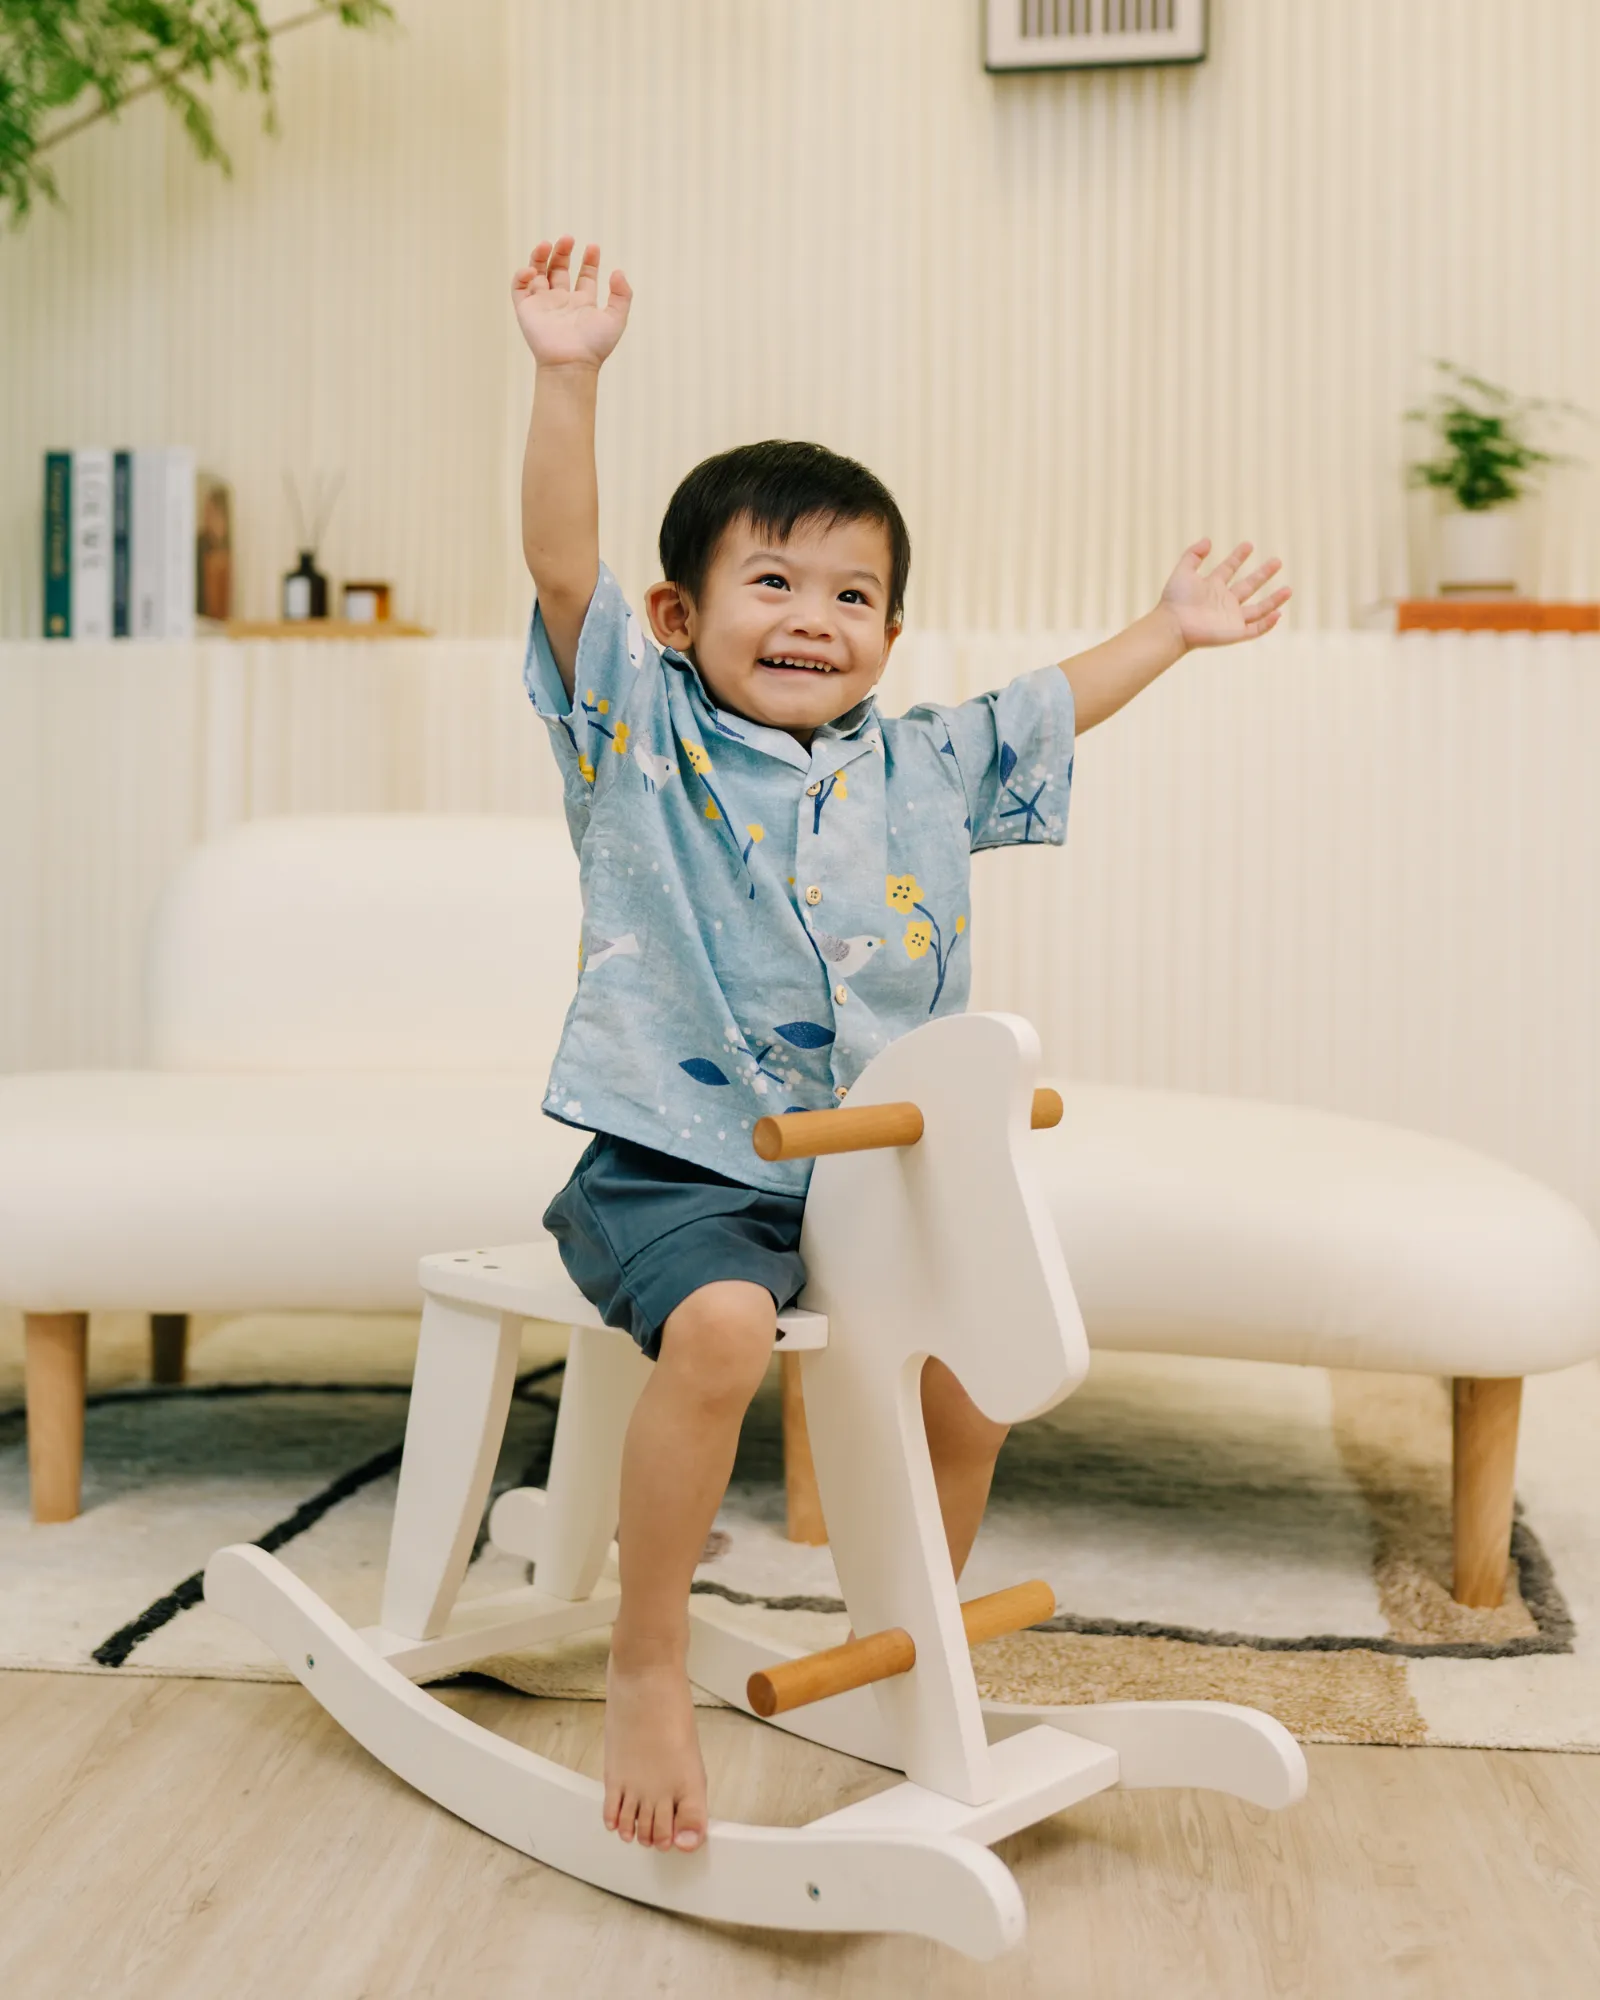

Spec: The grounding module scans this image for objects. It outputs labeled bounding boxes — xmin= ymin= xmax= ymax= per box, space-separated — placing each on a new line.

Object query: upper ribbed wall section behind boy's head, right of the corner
xmin=512 ymin=0 xmax=1600 ymax=630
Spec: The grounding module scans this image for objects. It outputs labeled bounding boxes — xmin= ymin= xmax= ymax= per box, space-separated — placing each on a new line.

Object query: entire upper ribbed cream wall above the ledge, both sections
xmin=0 ymin=0 xmax=1600 ymax=634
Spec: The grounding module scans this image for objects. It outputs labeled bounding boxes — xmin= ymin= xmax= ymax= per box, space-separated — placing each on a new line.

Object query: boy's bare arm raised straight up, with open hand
xmin=512 ymin=236 xmax=634 ymax=696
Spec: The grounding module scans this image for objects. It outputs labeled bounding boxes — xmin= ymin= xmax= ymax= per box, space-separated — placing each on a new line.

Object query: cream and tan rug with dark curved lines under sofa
xmin=0 ymin=1314 xmax=1600 ymax=1750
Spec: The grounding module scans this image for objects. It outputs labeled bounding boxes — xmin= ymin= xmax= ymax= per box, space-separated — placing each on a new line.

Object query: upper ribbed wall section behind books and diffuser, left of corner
xmin=0 ymin=0 xmax=514 ymax=636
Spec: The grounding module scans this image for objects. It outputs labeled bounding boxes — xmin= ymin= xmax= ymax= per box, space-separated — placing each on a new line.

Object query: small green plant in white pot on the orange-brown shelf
xmin=1406 ymin=362 xmax=1566 ymax=592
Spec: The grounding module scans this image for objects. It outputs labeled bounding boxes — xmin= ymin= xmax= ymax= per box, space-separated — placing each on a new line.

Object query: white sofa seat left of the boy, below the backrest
xmin=0 ymin=1070 xmax=586 ymax=1312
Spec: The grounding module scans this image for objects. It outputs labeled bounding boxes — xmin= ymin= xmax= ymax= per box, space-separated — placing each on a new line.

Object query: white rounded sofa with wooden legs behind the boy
xmin=0 ymin=816 xmax=1600 ymax=1602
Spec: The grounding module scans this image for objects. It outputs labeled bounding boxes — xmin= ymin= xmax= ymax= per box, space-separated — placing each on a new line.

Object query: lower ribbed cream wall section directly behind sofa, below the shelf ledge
xmin=0 ymin=634 xmax=1600 ymax=1222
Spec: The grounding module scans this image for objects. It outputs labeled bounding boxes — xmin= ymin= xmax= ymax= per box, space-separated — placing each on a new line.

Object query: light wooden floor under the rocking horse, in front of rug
xmin=0 ymin=1674 xmax=1600 ymax=2000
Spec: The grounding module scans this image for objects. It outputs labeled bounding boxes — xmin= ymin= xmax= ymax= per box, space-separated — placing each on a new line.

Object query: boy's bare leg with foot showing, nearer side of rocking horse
xmin=604 ymin=1278 xmax=778 ymax=1848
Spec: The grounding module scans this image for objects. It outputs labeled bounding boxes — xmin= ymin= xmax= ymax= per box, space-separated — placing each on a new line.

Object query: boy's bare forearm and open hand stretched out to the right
xmin=1060 ymin=540 xmax=1290 ymax=736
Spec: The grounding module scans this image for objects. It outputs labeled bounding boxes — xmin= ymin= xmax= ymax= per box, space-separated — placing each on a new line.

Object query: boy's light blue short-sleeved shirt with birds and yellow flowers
xmin=524 ymin=568 xmax=1072 ymax=1194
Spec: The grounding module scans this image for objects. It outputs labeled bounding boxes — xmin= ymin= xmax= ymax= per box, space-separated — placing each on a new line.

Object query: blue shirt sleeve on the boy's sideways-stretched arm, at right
xmin=906 ymin=666 xmax=1072 ymax=852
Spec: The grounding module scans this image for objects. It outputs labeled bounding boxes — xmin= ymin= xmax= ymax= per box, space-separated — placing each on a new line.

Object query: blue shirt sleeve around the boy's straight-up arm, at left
xmin=522 ymin=562 xmax=666 ymax=838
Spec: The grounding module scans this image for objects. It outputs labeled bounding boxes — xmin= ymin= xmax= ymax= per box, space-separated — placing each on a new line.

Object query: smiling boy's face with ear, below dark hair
xmin=646 ymin=520 xmax=900 ymax=744
